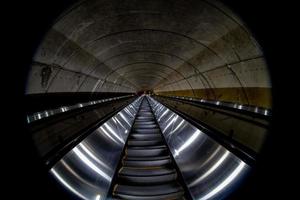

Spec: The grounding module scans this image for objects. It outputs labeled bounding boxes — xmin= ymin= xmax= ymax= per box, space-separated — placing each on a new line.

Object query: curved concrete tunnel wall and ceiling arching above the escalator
xmin=26 ymin=0 xmax=271 ymax=108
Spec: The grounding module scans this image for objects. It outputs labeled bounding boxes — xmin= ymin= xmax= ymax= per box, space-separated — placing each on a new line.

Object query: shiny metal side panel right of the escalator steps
xmin=147 ymin=96 xmax=250 ymax=200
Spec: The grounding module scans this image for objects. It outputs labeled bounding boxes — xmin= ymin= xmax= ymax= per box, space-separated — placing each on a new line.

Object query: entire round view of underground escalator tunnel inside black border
xmin=24 ymin=0 xmax=272 ymax=200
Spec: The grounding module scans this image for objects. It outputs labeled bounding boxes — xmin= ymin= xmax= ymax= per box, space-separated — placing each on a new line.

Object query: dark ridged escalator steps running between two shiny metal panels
xmin=110 ymin=97 xmax=188 ymax=200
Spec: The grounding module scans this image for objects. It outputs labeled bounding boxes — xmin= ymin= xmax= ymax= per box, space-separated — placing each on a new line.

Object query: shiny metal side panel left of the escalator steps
xmin=50 ymin=98 xmax=141 ymax=200
